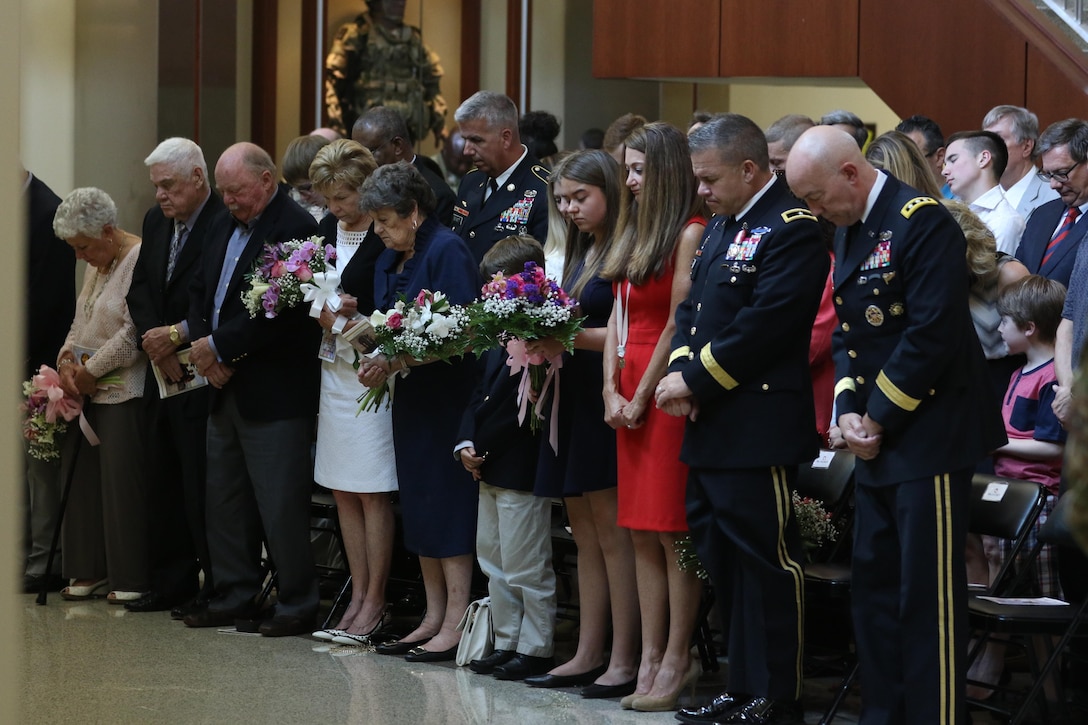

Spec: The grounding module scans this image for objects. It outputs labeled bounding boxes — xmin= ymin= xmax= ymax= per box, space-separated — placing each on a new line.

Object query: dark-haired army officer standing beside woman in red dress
xmin=656 ymin=113 xmax=829 ymax=724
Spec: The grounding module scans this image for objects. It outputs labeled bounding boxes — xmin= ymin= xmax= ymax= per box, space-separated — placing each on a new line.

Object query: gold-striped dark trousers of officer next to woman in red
xmin=687 ymin=466 xmax=804 ymax=700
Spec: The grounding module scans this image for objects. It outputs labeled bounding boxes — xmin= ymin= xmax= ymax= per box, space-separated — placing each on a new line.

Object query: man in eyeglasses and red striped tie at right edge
xmin=1016 ymin=119 xmax=1088 ymax=287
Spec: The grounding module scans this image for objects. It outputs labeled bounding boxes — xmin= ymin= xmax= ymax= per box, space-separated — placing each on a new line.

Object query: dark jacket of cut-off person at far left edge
xmin=24 ymin=174 xmax=75 ymax=378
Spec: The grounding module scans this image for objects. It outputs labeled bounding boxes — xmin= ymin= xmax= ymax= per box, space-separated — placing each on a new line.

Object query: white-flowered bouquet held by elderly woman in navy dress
xmin=359 ymin=290 xmax=469 ymax=413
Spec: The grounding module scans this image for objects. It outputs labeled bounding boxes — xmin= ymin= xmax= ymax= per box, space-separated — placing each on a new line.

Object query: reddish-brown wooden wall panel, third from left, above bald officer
xmin=858 ymin=0 xmax=1027 ymax=135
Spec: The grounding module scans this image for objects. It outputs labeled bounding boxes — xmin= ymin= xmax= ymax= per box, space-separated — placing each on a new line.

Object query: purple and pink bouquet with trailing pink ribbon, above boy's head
xmin=469 ymin=261 xmax=582 ymax=435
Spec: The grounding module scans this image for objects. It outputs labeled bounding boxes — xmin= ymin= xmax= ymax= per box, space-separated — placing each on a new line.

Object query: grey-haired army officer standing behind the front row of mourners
xmin=453 ymin=90 xmax=548 ymax=265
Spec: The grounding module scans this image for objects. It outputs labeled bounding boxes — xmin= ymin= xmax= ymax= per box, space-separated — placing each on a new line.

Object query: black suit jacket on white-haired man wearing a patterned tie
xmin=127 ymin=193 xmax=226 ymax=402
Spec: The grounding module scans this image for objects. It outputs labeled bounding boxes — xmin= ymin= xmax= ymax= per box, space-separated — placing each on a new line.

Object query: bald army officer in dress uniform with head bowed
xmin=786 ymin=126 xmax=1004 ymax=725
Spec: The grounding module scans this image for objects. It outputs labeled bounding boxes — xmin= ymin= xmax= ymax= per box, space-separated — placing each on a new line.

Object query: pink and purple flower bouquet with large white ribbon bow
xmin=242 ymin=236 xmax=339 ymax=319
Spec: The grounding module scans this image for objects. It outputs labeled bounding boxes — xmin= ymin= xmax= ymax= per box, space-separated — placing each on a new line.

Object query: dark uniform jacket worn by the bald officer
xmin=831 ymin=175 xmax=1005 ymax=486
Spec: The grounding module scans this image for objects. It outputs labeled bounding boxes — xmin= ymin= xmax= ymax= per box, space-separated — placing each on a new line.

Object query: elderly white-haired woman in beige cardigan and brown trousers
xmin=53 ymin=187 xmax=148 ymax=604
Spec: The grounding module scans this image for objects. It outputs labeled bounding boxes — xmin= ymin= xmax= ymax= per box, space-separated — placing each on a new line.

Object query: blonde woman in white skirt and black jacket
xmin=310 ymin=139 xmax=397 ymax=644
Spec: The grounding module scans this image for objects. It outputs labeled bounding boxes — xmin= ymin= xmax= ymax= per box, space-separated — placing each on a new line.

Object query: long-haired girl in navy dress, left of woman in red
xmin=526 ymin=150 xmax=639 ymax=698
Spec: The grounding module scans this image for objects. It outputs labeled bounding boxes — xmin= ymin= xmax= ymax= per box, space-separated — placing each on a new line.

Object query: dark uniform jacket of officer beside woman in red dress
xmin=669 ymin=179 xmax=830 ymax=468
